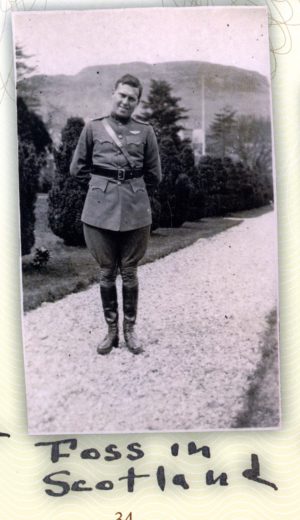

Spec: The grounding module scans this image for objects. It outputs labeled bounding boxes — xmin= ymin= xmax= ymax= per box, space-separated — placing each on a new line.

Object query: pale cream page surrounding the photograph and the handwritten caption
xmin=0 ymin=0 xmax=300 ymax=520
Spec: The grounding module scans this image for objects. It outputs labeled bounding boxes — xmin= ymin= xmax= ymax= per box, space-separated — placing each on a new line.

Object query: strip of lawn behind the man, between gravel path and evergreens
xmin=22 ymin=195 xmax=268 ymax=311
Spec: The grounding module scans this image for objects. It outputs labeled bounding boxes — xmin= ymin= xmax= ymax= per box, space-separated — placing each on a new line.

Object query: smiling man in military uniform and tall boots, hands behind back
xmin=70 ymin=74 xmax=161 ymax=354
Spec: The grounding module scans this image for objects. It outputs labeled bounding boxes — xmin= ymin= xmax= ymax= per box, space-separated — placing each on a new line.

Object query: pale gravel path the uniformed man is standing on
xmin=24 ymin=212 xmax=277 ymax=433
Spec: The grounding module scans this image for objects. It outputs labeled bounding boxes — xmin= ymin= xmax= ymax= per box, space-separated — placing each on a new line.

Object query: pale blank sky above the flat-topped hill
xmin=13 ymin=6 xmax=270 ymax=77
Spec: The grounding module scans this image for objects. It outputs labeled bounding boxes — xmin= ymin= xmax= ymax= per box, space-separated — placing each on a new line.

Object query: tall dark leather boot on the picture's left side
xmin=97 ymin=285 xmax=119 ymax=354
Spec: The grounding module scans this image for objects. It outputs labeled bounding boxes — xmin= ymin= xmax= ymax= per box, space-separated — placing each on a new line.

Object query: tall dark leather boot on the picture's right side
xmin=122 ymin=284 xmax=144 ymax=354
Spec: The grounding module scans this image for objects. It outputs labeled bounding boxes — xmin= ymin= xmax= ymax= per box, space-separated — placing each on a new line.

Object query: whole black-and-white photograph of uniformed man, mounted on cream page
xmin=13 ymin=6 xmax=280 ymax=434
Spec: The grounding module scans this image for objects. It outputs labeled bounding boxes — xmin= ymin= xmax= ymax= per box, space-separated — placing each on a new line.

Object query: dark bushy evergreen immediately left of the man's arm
xmin=48 ymin=117 xmax=88 ymax=246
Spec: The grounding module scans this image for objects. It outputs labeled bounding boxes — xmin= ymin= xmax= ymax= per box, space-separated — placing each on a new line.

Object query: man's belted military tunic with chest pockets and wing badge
xmin=70 ymin=116 xmax=161 ymax=231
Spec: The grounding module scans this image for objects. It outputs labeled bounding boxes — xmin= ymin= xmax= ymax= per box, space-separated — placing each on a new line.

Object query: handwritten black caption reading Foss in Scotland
xmin=0 ymin=433 xmax=278 ymax=497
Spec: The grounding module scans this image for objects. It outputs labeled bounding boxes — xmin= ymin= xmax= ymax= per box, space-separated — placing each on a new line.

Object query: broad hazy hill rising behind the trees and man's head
xmin=26 ymin=61 xmax=270 ymax=140
